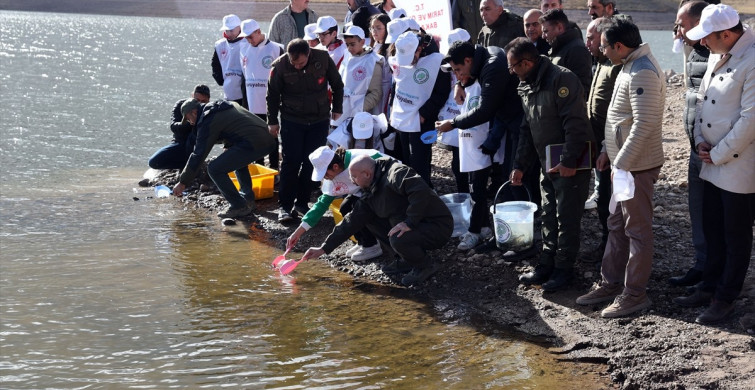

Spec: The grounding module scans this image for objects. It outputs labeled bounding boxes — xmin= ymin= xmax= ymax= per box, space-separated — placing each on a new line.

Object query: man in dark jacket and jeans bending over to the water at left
xmin=173 ymin=99 xmax=275 ymax=218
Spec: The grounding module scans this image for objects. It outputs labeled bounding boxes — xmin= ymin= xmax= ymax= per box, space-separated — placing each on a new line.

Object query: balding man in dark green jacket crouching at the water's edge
xmin=302 ymin=156 xmax=454 ymax=286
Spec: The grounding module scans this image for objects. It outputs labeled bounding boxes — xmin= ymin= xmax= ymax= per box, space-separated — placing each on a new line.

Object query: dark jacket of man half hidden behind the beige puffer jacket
xmin=587 ymin=59 xmax=621 ymax=150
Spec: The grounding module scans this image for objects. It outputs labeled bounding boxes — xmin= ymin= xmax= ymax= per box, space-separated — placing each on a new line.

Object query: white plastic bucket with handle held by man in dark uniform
xmin=490 ymin=181 xmax=537 ymax=252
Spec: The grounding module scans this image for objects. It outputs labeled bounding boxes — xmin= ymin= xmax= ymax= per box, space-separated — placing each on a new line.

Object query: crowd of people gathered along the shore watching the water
xmin=149 ymin=0 xmax=755 ymax=323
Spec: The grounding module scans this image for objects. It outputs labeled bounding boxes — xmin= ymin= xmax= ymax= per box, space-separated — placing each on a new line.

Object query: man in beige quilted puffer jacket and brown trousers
xmin=577 ymin=18 xmax=666 ymax=318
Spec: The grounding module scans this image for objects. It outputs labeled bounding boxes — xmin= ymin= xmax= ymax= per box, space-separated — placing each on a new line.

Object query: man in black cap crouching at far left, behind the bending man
xmin=148 ymin=84 xmax=210 ymax=169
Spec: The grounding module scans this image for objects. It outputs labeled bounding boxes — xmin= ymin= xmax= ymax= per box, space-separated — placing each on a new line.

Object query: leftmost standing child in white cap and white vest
xmin=212 ymin=14 xmax=245 ymax=105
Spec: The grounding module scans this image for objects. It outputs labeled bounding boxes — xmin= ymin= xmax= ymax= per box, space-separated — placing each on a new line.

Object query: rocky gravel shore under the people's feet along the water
xmin=141 ymin=80 xmax=755 ymax=389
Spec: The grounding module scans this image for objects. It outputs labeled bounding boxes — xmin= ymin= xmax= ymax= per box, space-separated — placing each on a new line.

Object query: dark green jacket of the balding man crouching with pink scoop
xmin=322 ymin=157 xmax=454 ymax=253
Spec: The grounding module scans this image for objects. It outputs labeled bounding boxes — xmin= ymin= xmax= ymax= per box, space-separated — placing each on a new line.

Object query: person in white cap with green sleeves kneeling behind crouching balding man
xmin=286 ymin=145 xmax=384 ymax=261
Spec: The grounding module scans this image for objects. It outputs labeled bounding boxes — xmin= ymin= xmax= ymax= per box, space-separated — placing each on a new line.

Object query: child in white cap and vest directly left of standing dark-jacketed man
xmin=239 ymin=19 xmax=283 ymax=170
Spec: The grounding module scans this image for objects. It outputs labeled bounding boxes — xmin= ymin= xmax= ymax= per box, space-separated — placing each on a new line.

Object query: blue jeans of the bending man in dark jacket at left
xmin=207 ymin=146 xmax=270 ymax=209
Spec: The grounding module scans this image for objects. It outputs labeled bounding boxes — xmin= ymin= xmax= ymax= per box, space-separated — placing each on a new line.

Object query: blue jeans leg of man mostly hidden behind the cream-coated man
xmin=687 ymin=152 xmax=708 ymax=271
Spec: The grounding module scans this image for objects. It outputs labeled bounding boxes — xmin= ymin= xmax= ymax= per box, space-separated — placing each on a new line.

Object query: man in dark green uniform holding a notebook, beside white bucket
xmin=505 ymin=38 xmax=595 ymax=292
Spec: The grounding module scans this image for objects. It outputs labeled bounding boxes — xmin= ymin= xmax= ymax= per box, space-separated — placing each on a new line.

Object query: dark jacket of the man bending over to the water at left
xmin=179 ymin=100 xmax=275 ymax=186
